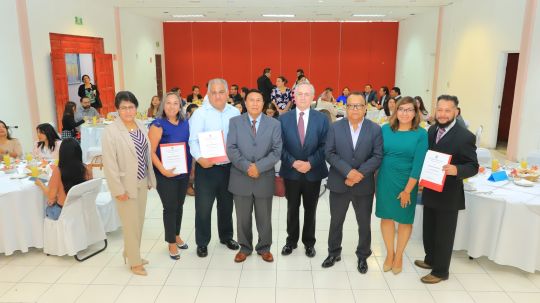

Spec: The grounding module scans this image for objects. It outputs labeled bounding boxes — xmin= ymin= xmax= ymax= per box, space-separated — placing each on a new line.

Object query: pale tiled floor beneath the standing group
xmin=0 ymin=191 xmax=540 ymax=303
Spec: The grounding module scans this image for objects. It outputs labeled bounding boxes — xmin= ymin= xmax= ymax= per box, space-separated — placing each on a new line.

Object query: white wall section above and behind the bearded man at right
xmin=437 ymin=0 xmax=525 ymax=148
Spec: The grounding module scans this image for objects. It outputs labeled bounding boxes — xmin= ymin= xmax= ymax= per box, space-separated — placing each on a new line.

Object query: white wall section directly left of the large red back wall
xmin=120 ymin=10 xmax=161 ymax=113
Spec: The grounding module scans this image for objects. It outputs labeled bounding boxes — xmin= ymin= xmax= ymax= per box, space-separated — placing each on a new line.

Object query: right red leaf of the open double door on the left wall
xmin=94 ymin=54 xmax=116 ymax=115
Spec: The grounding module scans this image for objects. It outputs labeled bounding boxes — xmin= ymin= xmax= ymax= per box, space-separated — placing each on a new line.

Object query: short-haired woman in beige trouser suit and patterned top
xmin=102 ymin=91 xmax=156 ymax=276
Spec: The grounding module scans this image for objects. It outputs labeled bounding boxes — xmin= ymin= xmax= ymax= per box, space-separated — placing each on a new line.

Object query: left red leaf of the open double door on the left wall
xmin=51 ymin=52 xmax=69 ymax=132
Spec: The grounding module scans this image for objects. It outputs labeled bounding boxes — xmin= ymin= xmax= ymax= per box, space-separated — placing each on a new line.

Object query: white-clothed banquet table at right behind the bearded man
xmin=413 ymin=170 xmax=540 ymax=272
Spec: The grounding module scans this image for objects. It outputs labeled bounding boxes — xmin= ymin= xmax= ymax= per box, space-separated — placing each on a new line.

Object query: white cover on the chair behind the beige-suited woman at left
xmin=43 ymin=179 xmax=107 ymax=256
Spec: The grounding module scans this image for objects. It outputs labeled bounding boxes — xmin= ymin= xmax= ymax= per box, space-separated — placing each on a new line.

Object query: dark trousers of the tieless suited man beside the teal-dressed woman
xmin=328 ymin=191 xmax=373 ymax=259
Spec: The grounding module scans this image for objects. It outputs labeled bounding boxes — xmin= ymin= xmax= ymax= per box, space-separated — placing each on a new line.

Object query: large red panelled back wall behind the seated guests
xmin=163 ymin=22 xmax=398 ymax=96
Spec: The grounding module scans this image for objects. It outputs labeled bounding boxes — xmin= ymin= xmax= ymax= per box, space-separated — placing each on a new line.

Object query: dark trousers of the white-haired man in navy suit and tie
xmin=284 ymin=176 xmax=321 ymax=247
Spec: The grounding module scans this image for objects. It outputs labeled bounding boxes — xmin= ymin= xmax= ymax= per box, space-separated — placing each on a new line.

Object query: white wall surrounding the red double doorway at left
xmin=27 ymin=0 xmax=118 ymax=125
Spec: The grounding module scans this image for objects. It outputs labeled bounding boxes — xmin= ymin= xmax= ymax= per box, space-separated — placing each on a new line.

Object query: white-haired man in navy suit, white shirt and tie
xmin=279 ymin=83 xmax=329 ymax=257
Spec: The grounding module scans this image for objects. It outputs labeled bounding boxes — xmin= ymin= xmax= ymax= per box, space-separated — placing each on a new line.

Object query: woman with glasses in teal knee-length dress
xmin=375 ymin=97 xmax=428 ymax=274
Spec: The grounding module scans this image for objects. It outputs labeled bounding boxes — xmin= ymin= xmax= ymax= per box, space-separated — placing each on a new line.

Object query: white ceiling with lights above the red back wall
xmin=116 ymin=0 xmax=452 ymax=21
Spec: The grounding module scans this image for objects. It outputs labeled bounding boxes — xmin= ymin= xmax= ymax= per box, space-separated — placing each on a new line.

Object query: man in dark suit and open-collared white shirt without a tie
xmin=322 ymin=93 xmax=383 ymax=274
